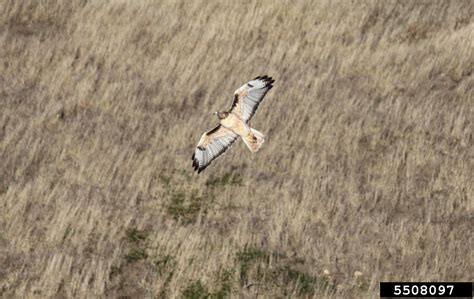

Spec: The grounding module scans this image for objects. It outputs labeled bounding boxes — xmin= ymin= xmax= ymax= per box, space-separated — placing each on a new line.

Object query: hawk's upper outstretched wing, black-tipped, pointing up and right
xmin=230 ymin=76 xmax=275 ymax=123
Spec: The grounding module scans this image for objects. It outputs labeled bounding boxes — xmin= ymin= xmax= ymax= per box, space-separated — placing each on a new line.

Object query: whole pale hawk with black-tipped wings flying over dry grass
xmin=192 ymin=76 xmax=275 ymax=173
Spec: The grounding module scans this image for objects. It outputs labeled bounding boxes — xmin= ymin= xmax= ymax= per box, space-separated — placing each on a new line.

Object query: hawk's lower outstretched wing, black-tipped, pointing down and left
xmin=192 ymin=125 xmax=239 ymax=173
